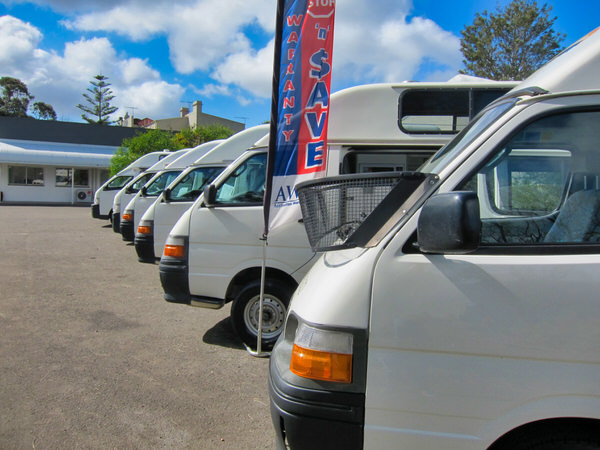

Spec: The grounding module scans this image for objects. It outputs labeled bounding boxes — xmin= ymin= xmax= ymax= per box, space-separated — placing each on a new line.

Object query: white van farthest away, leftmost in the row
xmin=92 ymin=151 xmax=170 ymax=219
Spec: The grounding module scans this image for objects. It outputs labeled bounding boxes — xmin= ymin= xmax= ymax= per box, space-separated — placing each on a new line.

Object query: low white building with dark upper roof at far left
xmin=0 ymin=116 xmax=143 ymax=204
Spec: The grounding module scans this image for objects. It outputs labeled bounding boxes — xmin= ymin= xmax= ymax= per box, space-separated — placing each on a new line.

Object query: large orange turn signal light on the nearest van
xmin=290 ymin=344 xmax=352 ymax=383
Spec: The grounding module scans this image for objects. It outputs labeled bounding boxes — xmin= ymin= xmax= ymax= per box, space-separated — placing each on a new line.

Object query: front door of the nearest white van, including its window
xmin=365 ymin=104 xmax=600 ymax=450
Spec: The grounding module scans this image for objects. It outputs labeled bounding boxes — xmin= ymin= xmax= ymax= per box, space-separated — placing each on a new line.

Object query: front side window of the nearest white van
xmin=457 ymin=111 xmax=600 ymax=246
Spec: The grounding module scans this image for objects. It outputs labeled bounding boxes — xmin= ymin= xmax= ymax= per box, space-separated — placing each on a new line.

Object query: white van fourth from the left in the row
xmin=134 ymin=125 xmax=269 ymax=263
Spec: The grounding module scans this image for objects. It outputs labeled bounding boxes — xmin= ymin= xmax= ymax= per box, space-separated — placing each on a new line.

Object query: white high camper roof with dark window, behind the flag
xmin=251 ymin=80 xmax=518 ymax=147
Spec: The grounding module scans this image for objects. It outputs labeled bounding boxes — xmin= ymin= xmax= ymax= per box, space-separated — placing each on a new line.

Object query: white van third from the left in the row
xmin=119 ymin=140 xmax=225 ymax=241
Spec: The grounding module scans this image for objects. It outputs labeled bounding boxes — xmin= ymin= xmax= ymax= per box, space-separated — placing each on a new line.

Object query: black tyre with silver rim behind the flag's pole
xmin=231 ymin=279 xmax=294 ymax=351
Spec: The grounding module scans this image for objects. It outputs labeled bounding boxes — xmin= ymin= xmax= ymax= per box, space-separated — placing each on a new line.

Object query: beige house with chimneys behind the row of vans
xmin=118 ymin=100 xmax=246 ymax=133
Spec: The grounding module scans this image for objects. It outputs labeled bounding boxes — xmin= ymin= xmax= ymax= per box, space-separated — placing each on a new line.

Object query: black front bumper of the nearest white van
xmin=269 ymin=348 xmax=365 ymax=450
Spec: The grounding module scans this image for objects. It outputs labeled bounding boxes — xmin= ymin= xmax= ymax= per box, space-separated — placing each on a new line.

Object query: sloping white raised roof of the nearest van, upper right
xmin=513 ymin=28 xmax=600 ymax=93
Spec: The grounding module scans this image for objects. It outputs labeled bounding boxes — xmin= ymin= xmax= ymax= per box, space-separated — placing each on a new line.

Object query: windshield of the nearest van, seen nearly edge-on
xmin=419 ymin=98 xmax=519 ymax=173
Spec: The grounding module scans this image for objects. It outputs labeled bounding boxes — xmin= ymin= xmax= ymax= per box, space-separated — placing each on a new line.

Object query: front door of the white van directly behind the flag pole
xmin=189 ymin=152 xmax=313 ymax=301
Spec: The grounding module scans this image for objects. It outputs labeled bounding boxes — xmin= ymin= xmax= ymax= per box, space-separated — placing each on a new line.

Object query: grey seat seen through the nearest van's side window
xmin=544 ymin=189 xmax=600 ymax=243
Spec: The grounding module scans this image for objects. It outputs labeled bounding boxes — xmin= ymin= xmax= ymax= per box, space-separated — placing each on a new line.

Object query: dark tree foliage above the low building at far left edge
xmin=0 ymin=77 xmax=56 ymax=120
